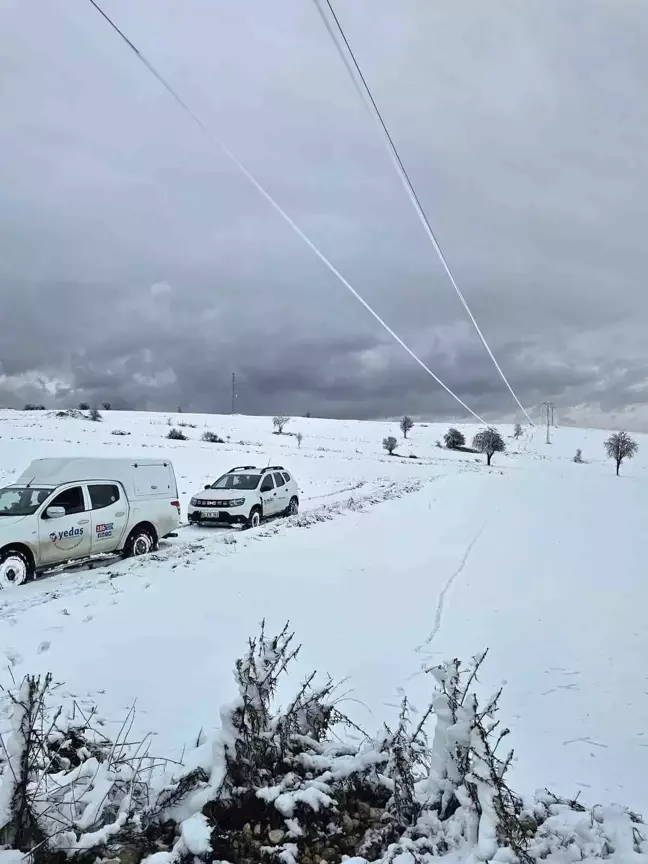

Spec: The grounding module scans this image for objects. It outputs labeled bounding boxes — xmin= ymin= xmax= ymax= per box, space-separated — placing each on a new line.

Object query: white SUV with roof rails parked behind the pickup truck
xmin=188 ymin=465 xmax=299 ymax=528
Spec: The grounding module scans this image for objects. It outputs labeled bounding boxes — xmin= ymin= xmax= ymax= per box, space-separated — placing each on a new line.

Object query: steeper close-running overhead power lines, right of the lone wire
xmin=314 ymin=0 xmax=533 ymax=425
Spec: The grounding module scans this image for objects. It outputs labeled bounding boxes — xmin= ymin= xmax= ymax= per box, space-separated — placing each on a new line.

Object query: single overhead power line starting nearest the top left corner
xmin=82 ymin=0 xmax=485 ymax=423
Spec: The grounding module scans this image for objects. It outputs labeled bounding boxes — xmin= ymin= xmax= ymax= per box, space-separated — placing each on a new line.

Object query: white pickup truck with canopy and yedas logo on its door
xmin=0 ymin=458 xmax=180 ymax=588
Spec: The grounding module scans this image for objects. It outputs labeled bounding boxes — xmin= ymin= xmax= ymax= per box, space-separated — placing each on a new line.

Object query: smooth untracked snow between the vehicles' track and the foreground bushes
xmin=0 ymin=456 xmax=648 ymax=809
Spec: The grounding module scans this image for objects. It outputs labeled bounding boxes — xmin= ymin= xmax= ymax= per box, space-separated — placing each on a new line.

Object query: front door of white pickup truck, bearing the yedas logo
xmin=38 ymin=485 xmax=90 ymax=567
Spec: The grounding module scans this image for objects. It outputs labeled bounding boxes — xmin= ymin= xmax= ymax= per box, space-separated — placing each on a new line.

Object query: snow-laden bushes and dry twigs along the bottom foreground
xmin=0 ymin=626 xmax=648 ymax=864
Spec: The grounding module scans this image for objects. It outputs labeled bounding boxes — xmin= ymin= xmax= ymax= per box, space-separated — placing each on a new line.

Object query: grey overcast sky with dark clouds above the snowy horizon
xmin=0 ymin=0 xmax=648 ymax=429
